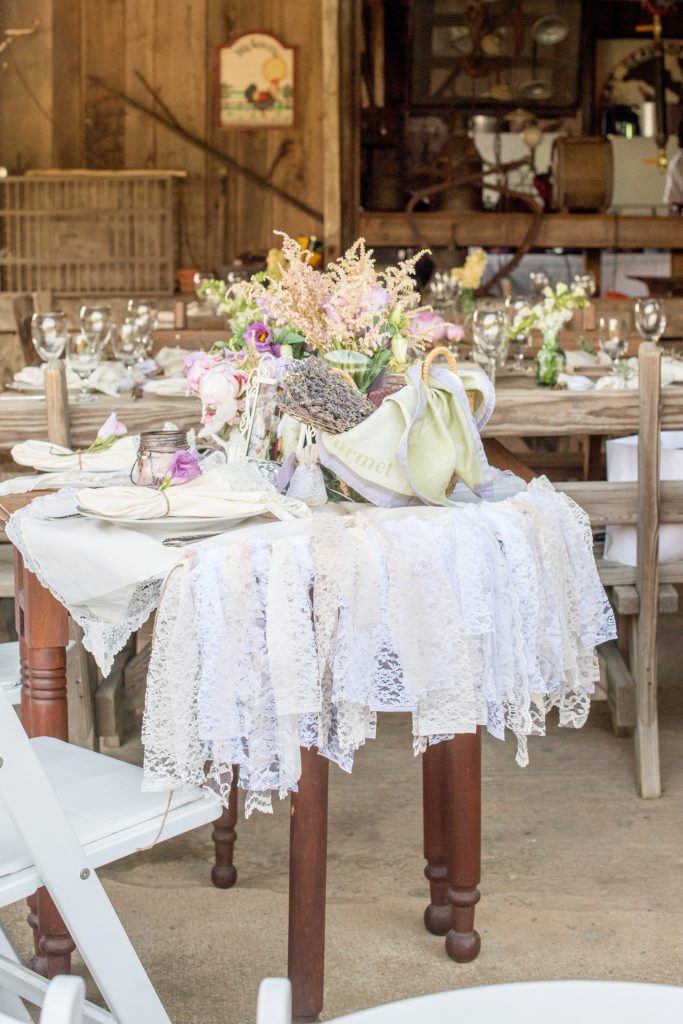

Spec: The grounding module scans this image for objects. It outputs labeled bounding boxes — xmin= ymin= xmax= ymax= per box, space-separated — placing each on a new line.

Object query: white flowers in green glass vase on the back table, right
xmin=510 ymin=282 xmax=589 ymax=387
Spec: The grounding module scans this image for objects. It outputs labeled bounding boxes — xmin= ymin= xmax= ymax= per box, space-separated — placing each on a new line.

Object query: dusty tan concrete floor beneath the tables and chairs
xmin=1 ymin=616 xmax=683 ymax=1024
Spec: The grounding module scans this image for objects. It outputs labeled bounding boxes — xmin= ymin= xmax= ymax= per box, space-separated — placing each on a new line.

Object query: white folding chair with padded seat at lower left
xmin=0 ymin=692 xmax=221 ymax=1024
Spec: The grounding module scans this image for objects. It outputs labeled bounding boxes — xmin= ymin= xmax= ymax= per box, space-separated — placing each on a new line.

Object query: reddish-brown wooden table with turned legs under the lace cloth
xmin=0 ymin=492 xmax=481 ymax=1024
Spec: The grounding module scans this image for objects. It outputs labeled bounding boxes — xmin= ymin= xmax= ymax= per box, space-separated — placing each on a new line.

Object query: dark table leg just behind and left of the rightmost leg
xmin=422 ymin=743 xmax=451 ymax=935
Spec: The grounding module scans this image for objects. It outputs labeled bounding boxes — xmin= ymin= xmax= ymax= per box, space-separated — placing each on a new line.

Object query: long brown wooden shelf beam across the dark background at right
xmin=358 ymin=212 xmax=683 ymax=250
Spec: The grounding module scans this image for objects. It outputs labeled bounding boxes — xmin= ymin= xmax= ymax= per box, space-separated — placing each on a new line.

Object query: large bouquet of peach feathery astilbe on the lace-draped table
xmin=239 ymin=232 xmax=429 ymax=392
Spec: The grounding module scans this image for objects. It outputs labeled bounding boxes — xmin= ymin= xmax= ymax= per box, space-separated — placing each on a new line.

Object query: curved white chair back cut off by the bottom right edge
xmin=256 ymin=978 xmax=683 ymax=1024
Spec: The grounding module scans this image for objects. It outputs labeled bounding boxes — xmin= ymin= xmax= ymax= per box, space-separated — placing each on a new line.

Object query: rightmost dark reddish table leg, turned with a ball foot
xmin=443 ymin=729 xmax=481 ymax=964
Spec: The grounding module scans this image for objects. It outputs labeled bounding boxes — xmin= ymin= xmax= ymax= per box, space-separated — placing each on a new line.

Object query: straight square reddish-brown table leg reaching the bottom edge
xmin=287 ymin=748 xmax=330 ymax=1024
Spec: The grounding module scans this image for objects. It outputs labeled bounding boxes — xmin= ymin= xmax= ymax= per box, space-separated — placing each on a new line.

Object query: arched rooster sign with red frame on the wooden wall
xmin=218 ymin=32 xmax=294 ymax=128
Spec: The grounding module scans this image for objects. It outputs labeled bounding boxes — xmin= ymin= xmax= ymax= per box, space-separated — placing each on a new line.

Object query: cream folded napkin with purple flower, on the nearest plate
xmin=76 ymin=463 xmax=311 ymax=519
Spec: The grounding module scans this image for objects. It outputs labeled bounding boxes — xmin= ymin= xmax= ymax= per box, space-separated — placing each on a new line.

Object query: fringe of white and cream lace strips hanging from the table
xmin=142 ymin=480 xmax=615 ymax=813
